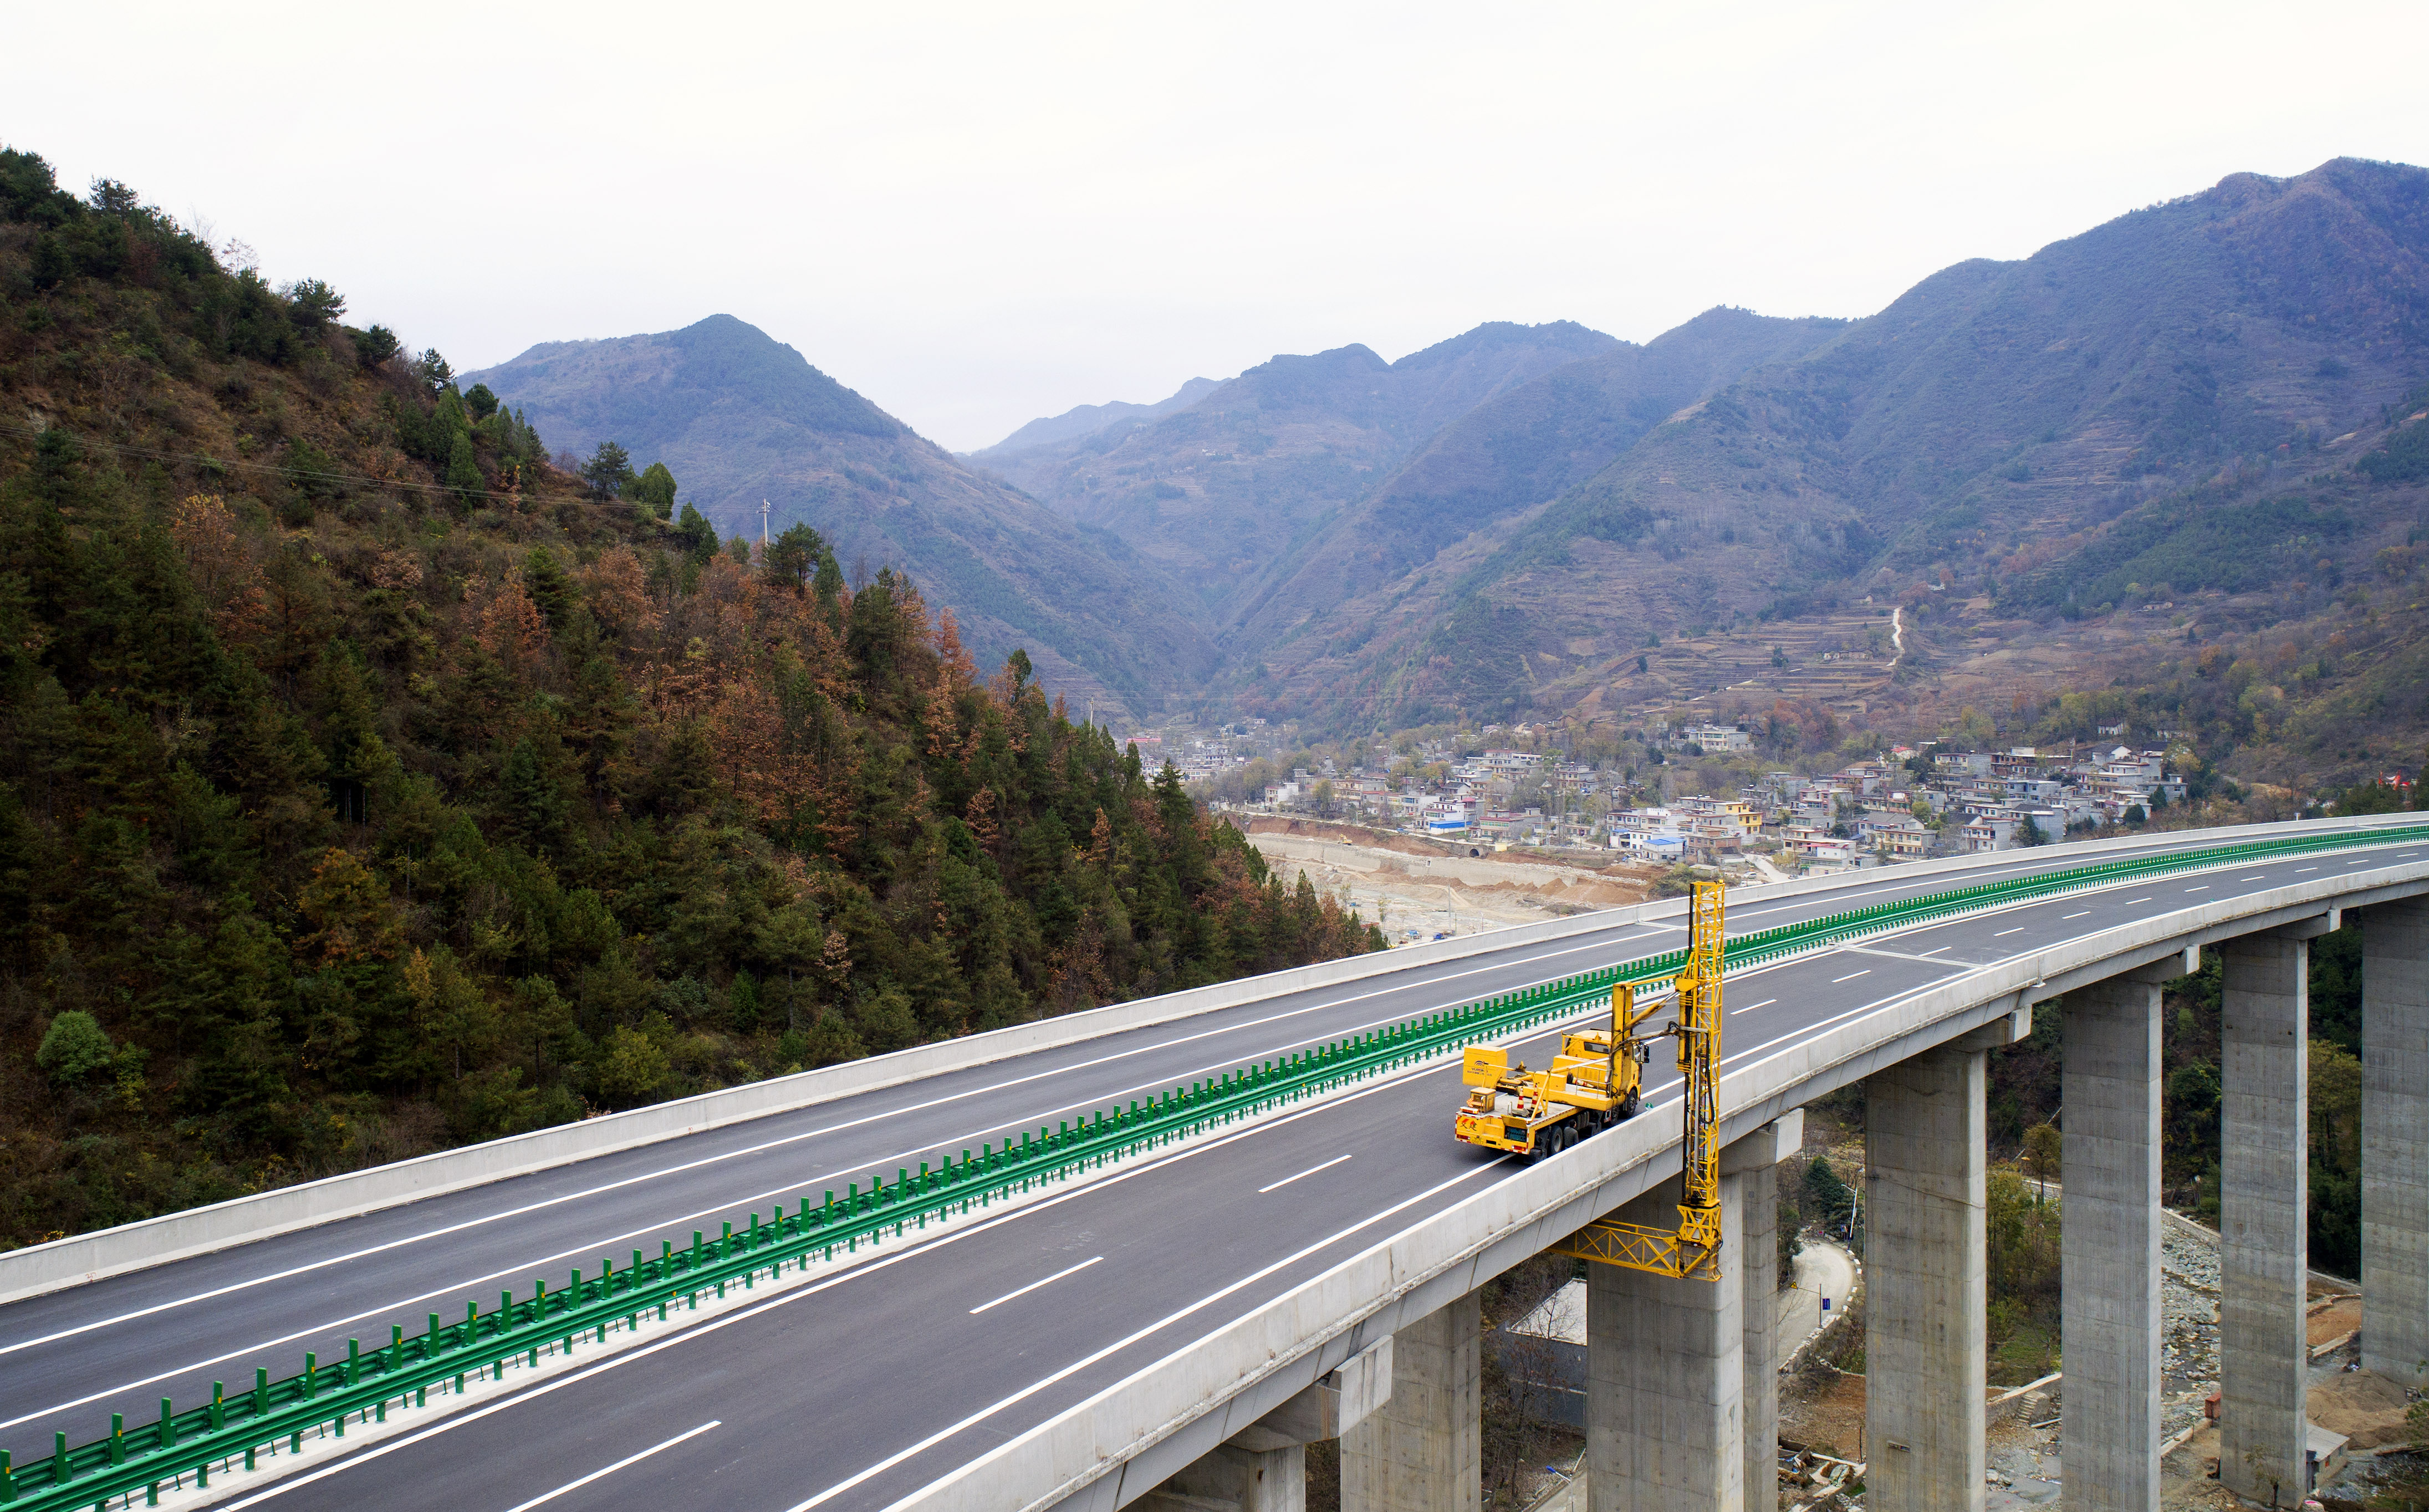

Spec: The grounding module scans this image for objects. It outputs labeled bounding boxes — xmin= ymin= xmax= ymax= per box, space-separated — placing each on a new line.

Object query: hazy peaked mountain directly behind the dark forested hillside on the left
xmin=464 ymin=315 xmax=1212 ymax=711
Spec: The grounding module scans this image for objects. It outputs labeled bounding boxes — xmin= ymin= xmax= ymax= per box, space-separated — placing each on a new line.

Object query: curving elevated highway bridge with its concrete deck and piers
xmin=0 ymin=815 xmax=2429 ymax=1512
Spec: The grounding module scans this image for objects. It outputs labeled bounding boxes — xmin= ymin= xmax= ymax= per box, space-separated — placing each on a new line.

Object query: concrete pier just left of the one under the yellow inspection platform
xmin=1341 ymin=1291 xmax=1484 ymax=1512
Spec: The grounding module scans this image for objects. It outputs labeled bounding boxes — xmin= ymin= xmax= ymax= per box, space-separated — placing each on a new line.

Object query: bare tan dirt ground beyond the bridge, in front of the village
xmin=1246 ymin=815 xmax=1654 ymax=944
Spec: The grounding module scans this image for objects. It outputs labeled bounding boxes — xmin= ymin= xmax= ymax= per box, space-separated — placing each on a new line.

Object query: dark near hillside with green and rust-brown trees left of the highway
xmin=0 ymin=153 xmax=1382 ymax=1245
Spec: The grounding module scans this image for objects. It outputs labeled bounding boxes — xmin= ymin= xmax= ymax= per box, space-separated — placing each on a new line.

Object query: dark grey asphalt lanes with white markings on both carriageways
xmin=0 ymin=832 xmax=2429 ymax=1512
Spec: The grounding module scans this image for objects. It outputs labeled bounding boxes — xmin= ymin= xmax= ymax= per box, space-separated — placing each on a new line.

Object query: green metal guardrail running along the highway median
xmin=0 ymin=825 xmax=2429 ymax=1512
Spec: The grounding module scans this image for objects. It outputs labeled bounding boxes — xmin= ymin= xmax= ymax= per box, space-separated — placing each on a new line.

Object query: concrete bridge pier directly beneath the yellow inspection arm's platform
xmin=1586 ymin=1174 xmax=1747 ymax=1512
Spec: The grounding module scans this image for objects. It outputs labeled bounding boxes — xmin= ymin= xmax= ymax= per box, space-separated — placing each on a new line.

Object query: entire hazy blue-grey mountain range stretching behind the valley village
xmin=466 ymin=160 xmax=2429 ymax=747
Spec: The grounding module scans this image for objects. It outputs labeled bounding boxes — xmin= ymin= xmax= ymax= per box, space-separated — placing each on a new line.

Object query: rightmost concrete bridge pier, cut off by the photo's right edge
xmin=2361 ymin=898 xmax=2429 ymax=1386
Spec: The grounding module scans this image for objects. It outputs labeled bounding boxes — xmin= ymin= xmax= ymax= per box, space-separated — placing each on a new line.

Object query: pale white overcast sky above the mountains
xmin=14 ymin=0 xmax=2429 ymax=449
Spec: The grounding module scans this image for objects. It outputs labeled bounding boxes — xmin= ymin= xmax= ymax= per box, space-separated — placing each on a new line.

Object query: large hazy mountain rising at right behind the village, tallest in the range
xmin=1263 ymin=160 xmax=2429 ymax=723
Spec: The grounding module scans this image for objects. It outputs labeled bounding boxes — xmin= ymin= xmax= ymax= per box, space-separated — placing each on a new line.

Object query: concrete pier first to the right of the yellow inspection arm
xmin=1863 ymin=1041 xmax=1989 ymax=1512
